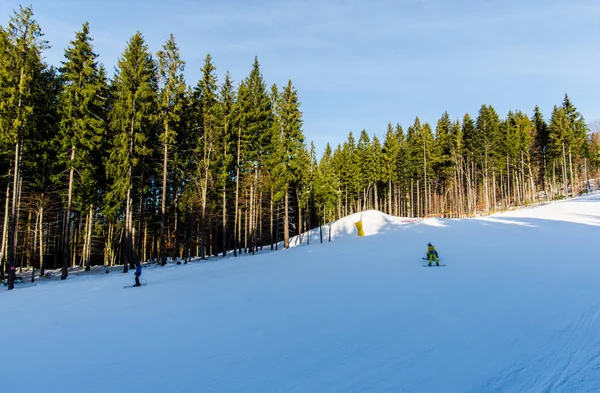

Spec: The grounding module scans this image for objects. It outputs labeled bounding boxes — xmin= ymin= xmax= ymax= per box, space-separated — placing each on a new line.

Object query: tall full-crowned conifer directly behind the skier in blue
xmin=107 ymin=32 xmax=158 ymax=273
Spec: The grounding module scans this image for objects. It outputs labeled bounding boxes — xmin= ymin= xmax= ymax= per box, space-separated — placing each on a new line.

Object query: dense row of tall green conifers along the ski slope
xmin=0 ymin=8 xmax=600 ymax=288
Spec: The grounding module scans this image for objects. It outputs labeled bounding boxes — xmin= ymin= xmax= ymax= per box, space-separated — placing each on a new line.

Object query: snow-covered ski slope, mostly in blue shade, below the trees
xmin=0 ymin=195 xmax=600 ymax=393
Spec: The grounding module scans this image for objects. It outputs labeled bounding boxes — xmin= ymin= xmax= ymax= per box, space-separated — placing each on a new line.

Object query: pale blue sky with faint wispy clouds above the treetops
xmin=0 ymin=0 xmax=600 ymax=153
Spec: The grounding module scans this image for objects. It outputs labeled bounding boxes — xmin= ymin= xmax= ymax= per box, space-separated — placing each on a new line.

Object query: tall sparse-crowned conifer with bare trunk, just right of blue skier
xmin=157 ymin=34 xmax=186 ymax=266
